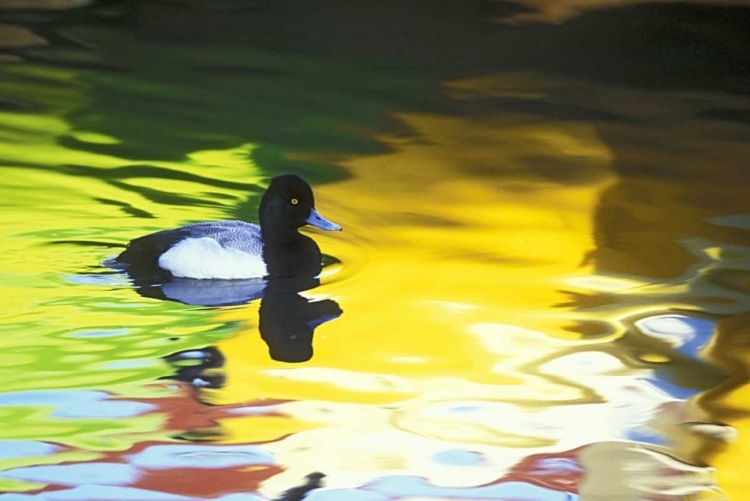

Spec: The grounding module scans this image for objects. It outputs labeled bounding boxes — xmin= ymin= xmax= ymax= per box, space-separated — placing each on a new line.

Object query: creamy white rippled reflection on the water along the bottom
xmin=250 ymin=315 xmax=719 ymax=501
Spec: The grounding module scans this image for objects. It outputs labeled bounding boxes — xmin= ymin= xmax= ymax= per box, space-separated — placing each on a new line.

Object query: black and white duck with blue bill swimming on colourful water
xmin=105 ymin=174 xmax=341 ymax=280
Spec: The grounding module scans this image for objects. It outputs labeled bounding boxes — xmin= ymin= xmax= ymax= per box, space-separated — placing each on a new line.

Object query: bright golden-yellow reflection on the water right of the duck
xmin=211 ymin=107 xmax=615 ymax=403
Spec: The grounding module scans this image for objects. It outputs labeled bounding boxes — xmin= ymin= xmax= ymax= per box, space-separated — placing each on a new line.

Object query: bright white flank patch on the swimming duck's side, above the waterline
xmin=159 ymin=237 xmax=266 ymax=280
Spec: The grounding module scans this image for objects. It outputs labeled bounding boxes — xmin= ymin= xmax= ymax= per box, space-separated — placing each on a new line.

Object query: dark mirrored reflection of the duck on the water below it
xmin=133 ymin=277 xmax=343 ymax=364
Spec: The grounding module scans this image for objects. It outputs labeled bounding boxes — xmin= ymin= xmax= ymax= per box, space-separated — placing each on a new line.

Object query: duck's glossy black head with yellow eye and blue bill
xmin=259 ymin=174 xmax=341 ymax=235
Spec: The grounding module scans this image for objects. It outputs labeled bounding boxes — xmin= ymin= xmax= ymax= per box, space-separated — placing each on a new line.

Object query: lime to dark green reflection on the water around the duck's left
xmin=0 ymin=18 xmax=452 ymax=476
